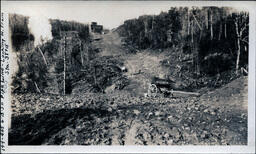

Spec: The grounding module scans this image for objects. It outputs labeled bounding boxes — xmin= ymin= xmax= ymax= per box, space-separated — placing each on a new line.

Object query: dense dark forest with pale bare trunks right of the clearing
xmin=117 ymin=7 xmax=249 ymax=76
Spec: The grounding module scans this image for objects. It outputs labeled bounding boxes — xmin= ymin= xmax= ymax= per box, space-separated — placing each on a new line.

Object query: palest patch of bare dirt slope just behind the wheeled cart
xmin=125 ymin=51 xmax=168 ymax=95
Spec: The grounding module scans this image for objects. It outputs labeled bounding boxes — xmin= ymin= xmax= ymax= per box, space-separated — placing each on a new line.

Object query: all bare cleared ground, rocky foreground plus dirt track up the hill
xmin=9 ymin=30 xmax=248 ymax=145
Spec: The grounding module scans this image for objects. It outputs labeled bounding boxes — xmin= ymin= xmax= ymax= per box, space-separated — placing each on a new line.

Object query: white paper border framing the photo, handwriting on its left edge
xmin=1 ymin=1 xmax=256 ymax=153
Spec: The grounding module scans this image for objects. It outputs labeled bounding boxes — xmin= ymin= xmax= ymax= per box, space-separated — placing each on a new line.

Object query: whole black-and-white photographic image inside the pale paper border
xmin=1 ymin=1 xmax=255 ymax=153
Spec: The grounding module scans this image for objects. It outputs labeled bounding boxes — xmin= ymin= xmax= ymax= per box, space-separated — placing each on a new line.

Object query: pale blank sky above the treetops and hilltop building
xmin=1 ymin=1 xmax=251 ymax=29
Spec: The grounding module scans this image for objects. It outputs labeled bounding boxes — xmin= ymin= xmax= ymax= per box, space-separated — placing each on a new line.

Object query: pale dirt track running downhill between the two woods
xmin=94 ymin=32 xmax=167 ymax=96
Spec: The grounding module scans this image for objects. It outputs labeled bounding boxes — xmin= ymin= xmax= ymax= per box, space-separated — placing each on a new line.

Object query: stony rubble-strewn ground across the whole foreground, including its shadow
xmin=9 ymin=88 xmax=247 ymax=145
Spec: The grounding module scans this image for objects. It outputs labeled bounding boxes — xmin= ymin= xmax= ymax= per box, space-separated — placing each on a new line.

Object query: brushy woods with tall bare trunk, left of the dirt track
xmin=9 ymin=14 xmax=126 ymax=94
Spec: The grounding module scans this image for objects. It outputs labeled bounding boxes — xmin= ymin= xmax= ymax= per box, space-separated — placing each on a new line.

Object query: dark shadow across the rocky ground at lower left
xmin=9 ymin=108 xmax=110 ymax=145
